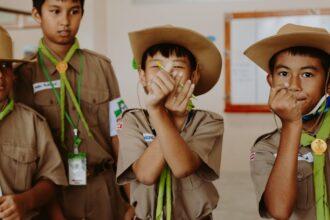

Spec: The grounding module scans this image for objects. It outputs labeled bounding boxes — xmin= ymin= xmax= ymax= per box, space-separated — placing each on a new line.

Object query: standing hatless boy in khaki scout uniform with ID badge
xmin=16 ymin=0 xmax=128 ymax=220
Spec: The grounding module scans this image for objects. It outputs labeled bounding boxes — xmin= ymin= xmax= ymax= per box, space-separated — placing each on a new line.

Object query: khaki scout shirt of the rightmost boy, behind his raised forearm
xmin=250 ymin=131 xmax=330 ymax=220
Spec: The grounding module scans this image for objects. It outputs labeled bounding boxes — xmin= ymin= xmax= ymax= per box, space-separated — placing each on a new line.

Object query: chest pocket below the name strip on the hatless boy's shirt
xmin=34 ymin=89 xmax=61 ymax=131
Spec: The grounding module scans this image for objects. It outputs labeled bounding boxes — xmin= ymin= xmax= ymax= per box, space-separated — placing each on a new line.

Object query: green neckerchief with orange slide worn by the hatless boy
xmin=39 ymin=39 xmax=93 ymax=147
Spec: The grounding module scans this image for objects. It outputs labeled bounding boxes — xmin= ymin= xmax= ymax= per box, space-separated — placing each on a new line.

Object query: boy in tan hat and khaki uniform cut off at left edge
xmin=0 ymin=27 xmax=67 ymax=220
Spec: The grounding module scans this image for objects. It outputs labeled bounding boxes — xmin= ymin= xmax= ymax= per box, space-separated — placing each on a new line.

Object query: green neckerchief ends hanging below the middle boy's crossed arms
xmin=156 ymin=166 xmax=172 ymax=220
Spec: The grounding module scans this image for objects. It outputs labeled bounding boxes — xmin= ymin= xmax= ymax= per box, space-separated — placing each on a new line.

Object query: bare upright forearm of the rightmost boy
xmin=264 ymin=122 xmax=302 ymax=219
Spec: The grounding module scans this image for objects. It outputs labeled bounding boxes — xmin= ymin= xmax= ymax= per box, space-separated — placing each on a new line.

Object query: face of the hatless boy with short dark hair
xmin=32 ymin=0 xmax=83 ymax=45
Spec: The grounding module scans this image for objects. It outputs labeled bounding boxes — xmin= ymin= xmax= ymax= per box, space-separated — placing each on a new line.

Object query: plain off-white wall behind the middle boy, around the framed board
xmin=106 ymin=0 xmax=330 ymax=172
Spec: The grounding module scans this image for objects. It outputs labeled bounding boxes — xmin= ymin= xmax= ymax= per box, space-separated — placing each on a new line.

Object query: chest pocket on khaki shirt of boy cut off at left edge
xmin=0 ymin=143 xmax=37 ymax=192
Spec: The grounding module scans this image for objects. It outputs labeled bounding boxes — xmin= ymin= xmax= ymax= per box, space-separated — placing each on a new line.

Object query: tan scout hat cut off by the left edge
xmin=0 ymin=26 xmax=30 ymax=62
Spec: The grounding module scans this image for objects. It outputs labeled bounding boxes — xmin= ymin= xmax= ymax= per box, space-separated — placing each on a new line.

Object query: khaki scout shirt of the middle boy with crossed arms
xmin=117 ymin=109 xmax=223 ymax=220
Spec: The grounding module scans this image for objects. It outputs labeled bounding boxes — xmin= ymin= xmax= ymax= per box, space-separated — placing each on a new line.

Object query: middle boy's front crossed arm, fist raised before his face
xmin=146 ymin=72 xmax=201 ymax=178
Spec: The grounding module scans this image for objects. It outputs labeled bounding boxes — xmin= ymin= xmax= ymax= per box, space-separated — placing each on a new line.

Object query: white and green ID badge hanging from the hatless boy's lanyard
xmin=69 ymin=152 xmax=87 ymax=186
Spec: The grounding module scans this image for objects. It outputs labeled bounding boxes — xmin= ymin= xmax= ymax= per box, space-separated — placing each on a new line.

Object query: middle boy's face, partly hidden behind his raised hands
xmin=140 ymin=52 xmax=194 ymax=91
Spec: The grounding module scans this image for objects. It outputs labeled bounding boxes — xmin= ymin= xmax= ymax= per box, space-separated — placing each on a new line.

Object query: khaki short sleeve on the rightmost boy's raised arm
xmin=250 ymin=141 xmax=275 ymax=218
